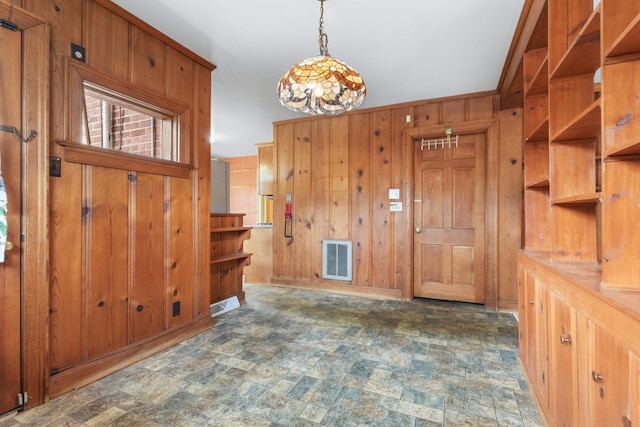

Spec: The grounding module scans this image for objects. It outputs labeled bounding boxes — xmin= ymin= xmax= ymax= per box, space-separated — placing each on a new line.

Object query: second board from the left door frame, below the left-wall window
xmin=83 ymin=166 xmax=129 ymax=360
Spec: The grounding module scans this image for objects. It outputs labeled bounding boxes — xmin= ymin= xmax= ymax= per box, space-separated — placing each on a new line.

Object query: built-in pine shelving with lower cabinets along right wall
xmin=518 ymin=0 xmax=640 ymax=425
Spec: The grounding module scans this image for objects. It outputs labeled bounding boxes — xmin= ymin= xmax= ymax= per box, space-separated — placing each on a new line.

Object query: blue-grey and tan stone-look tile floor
xmin=2 ymin=285 xmax=543 ymax=427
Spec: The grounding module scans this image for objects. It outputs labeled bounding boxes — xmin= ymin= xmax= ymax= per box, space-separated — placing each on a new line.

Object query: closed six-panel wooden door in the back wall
xmin=413 ymin=133 xmax=486 ymax=303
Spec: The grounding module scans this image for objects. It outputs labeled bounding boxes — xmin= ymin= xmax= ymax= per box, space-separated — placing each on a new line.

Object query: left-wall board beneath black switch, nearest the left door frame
xmin=49 ymin=164 xmax=84 ymax=372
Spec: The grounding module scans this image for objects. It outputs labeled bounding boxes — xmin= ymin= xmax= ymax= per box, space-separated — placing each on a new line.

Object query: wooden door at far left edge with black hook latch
xmin=0 ymin=28 xmax=22 ymax=414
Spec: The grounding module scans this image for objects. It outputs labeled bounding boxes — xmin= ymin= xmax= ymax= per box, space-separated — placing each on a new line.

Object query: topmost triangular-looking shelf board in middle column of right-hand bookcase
xmin=551 ymin=5 xmax=600 ymax=79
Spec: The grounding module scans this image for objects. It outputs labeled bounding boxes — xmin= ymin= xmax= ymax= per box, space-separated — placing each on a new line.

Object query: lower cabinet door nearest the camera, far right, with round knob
xmin=580 ymin=325 xmax=632 ymax=427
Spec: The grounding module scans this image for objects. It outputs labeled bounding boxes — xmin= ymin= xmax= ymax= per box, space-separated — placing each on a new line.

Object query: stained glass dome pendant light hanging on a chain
xmin=277 ymin=0 xmax=367 ymax=115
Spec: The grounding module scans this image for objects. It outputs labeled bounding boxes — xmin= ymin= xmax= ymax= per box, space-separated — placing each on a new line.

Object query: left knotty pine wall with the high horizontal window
xmin=18 ymin=0 xmax=215 ymax=405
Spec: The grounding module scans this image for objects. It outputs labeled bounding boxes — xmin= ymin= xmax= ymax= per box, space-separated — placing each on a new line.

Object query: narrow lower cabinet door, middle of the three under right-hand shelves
xmin=549 ymin=292 xmax=578 ymax=427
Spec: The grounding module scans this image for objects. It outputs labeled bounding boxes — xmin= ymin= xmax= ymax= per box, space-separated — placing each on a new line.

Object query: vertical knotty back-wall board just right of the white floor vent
xmin=349 ymin=114 xmax=374 ymax=286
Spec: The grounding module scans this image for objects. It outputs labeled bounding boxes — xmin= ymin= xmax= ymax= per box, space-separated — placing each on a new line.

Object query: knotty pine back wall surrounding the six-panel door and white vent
xmin=272 ymin=93 xmax=522 ymax=309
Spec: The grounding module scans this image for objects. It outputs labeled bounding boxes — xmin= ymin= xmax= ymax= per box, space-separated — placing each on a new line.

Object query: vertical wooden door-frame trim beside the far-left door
xmin=21 ymin=18 xmax=50 ymax=409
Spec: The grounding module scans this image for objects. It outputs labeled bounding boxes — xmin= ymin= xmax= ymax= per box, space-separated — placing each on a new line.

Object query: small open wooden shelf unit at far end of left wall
xmin=209 ymin=214 xmax=251 ymax=304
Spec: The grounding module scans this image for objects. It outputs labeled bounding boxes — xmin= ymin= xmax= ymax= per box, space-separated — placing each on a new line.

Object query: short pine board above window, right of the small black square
xmin=83 ymin=1 xmax=129 ymax=80
